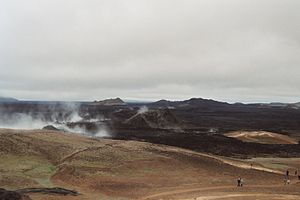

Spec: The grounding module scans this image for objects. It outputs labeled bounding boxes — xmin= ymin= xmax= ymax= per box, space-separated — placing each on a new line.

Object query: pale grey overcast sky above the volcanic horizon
xmin=0 ymin=0 xmax=300 ymax=102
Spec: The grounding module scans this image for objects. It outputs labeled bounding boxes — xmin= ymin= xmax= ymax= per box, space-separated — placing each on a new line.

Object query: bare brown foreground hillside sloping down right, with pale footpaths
xmin=0 ymin=129 xmax=300 ymax=200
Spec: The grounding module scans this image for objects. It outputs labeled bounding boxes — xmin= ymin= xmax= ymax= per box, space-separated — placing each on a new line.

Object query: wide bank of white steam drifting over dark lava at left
xmin=0 ymin=102 xmax=110 ymax=137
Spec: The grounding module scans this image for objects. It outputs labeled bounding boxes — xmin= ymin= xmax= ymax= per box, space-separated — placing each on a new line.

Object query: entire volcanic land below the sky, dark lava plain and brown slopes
xmin=0 ymin=98 xmax=300 ymax=200
